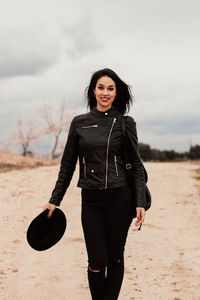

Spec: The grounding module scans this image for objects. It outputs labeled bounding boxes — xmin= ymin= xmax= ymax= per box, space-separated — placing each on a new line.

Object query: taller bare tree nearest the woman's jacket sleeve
xmin=37 ymin=100 xmax=76 ymax=159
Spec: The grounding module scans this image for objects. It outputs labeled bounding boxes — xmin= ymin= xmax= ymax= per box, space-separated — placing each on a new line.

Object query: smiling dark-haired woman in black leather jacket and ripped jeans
xmin=43 ymin=69 xmax=145 ymax=300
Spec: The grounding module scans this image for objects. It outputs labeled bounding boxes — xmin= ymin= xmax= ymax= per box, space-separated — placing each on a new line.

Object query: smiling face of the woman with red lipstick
xmin=94 ymin=76 xmax=116 ymax=111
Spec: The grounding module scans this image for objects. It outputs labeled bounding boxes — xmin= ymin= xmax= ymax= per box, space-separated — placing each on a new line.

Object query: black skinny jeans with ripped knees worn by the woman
xmin=81 ymin=187 xmax=132 ymax=300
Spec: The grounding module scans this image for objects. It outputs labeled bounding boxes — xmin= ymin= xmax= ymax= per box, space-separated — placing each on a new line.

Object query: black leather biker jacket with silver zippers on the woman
xmin=49 ymin=107 xmax=145 ymax=207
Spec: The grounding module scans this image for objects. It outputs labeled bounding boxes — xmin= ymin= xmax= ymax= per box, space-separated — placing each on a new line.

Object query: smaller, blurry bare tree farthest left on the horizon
xmin=10 ymin=119 xmax=43 ymax=156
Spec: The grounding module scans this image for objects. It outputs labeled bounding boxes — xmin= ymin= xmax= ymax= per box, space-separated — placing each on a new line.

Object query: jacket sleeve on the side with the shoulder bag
xmin=126 ymin=116 xmax=146 ymax=208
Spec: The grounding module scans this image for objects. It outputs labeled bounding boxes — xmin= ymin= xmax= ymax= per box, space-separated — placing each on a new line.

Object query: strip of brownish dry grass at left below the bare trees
xmin=0 ymin=152 xmax=58 ymax=173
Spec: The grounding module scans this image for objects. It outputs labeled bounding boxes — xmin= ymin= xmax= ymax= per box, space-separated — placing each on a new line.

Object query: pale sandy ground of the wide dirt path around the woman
xmin=0 ymin=162 xmax=200 ymax=300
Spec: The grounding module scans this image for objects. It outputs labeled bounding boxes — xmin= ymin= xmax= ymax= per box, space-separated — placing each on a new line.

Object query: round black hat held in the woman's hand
xmin=26 ymin=208 xmax=67 ymax=251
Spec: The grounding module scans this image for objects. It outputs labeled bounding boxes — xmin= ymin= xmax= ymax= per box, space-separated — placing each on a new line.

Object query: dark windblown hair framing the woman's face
xmin=85 ymin=68 xmax=133 ymax=115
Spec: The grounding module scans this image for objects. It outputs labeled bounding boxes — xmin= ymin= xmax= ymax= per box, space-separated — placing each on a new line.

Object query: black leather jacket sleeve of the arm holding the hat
xmin=49 ymin=117 xmax=78 ymax=206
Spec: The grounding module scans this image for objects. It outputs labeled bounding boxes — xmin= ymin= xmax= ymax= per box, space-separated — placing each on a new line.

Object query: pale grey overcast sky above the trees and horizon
xmin=0 ymin=0 xmax=200 ymax=151
